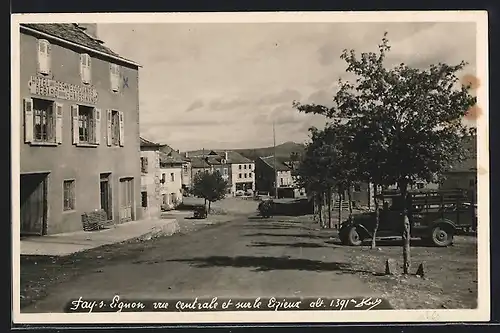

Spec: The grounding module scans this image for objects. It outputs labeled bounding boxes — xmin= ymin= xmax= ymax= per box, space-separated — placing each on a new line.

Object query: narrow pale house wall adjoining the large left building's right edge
xmin=140 ymin=138 xmax=161 ymax=218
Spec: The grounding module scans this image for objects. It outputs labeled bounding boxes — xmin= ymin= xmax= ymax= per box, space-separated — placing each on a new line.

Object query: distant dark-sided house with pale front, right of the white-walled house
xmin=255 ymin=156 xmax=305 ymax=198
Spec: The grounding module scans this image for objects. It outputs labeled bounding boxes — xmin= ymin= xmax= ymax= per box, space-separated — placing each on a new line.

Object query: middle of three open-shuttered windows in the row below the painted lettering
xmin=71 ymin=104 xmax=101 ymax=145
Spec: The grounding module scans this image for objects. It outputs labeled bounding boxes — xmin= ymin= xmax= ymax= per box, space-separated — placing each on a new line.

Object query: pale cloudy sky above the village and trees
xmin=97 ymin=22 xmax=476 ymax=151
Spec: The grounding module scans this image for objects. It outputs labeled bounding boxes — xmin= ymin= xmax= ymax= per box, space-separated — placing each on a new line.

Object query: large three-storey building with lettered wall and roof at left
xmin=18 ymin=24 xmax=142 ymax=235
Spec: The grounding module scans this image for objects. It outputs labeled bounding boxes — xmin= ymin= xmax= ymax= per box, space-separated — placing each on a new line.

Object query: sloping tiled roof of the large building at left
xmin=20 ymin=23 xmax=139 ymax=66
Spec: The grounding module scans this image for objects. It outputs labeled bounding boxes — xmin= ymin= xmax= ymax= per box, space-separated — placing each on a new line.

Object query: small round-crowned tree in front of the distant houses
xmin=191 ymin=171 xmax=228 ymax=212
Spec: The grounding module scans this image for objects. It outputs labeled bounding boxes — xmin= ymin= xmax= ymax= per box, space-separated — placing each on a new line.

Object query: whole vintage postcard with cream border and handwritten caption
xmin=11 ymin=11 xmax=490 ymax=325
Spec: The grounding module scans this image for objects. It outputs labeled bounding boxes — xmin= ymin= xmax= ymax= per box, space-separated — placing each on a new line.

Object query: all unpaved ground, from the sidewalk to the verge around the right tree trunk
xmin=21 ymin=209 xmax=477 ymax=312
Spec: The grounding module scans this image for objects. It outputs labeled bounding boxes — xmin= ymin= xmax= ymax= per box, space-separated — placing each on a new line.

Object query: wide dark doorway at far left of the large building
xmin=20 ymin=173 xmax=48 ymax=236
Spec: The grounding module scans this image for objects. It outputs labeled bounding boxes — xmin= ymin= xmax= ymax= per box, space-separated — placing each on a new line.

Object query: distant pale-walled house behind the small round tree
xmin=184 ymin=150 xmax=255 ymax=195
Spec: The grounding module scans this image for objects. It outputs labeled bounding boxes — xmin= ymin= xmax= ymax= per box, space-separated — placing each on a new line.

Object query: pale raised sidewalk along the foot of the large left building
xmin=20 ymin=219 xmax=179 ymax=256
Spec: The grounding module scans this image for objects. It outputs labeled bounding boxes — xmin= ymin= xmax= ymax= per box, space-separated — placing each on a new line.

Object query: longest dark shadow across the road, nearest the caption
xmin=168 ymin=256 xmax=361 ymax=273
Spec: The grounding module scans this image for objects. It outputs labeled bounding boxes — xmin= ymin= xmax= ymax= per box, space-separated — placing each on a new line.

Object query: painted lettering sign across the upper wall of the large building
xmin=28 ymin=76 xmax=97 ymax=104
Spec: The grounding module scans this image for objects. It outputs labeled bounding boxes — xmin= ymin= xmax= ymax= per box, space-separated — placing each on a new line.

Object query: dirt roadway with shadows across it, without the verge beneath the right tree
xmin=23 ymin=213 xmax=373 ymax=312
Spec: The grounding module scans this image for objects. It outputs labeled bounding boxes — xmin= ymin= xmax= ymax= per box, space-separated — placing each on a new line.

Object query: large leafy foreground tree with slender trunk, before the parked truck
xmin=296 ymin=34 xmax=476 ymax=274
